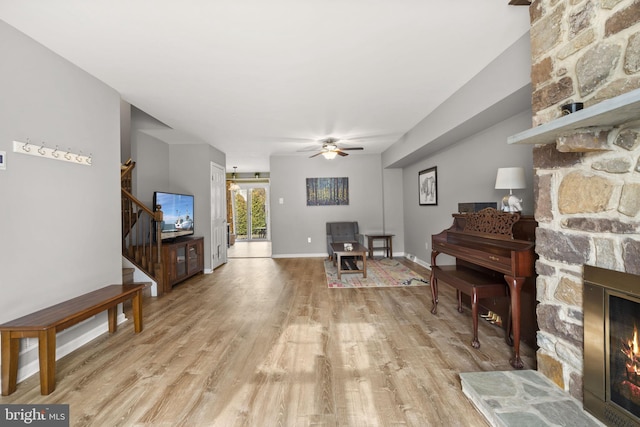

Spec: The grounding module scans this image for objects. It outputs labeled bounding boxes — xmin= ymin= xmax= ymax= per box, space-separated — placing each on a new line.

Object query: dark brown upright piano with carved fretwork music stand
xmin=431 ymin=208 xmax=538 ymax=369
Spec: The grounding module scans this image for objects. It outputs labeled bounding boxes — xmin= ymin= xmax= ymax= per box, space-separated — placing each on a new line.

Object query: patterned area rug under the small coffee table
xmin=324 ymin=258 xmax=428 ymax=288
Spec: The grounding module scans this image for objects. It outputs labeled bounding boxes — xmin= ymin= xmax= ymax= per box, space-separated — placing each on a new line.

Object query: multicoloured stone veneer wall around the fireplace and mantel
xmin=529 ymin=0 xmax=640 ymax=399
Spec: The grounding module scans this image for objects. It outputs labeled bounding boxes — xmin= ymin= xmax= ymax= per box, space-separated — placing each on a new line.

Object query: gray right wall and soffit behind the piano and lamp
xmin=382 ymin=34 xmax=533 ymax=264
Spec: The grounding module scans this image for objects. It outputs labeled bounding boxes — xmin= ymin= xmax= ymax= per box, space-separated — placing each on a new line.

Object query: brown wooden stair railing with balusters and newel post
xmin=120 ymin=159 xmax=164 ymax=296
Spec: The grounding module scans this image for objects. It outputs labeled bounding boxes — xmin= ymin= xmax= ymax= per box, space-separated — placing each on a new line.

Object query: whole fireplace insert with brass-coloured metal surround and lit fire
xmin=583 ymin=265 xmax=640 ymax=426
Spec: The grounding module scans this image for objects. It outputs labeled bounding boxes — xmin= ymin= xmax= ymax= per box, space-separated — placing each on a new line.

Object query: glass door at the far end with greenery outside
xmin=231 ymin=183 xmax=270 ymax=241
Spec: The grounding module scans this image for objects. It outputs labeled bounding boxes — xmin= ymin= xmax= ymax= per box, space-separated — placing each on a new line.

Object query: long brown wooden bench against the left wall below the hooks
xmin=0 ymin=283 xmax=149 ymax=396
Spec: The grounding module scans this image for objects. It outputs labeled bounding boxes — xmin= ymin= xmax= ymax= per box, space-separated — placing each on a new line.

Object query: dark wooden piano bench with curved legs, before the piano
xmin=431 ymin=265 xmax=509 ymax=348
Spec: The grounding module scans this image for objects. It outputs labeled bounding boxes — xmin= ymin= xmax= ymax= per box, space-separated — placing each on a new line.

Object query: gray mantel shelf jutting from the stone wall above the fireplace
xmin=507 ymin=89 xmax=640 ymax=144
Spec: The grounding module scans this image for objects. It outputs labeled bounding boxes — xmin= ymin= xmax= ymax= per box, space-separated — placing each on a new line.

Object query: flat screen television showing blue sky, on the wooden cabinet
xmin=153 ymin=191 xmax=195 ymax=240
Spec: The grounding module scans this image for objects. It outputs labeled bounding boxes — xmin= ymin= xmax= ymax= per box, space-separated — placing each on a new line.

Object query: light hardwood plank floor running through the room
xmin=0 ymin=258 xmax=534 ymax=427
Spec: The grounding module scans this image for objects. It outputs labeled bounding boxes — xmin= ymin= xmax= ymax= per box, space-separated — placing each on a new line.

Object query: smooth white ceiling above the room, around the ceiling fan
xmin=0 ymin=0 xmax=529 ymax=172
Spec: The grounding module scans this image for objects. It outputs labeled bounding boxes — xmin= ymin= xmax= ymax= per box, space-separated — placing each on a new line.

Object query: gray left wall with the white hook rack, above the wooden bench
xmin=0 ymin=21 xmax=122 ymax=372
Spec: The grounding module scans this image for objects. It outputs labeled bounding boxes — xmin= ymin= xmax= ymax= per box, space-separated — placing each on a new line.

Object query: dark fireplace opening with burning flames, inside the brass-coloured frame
xmin=609 ymin=294 xmax=640 ymax=418
